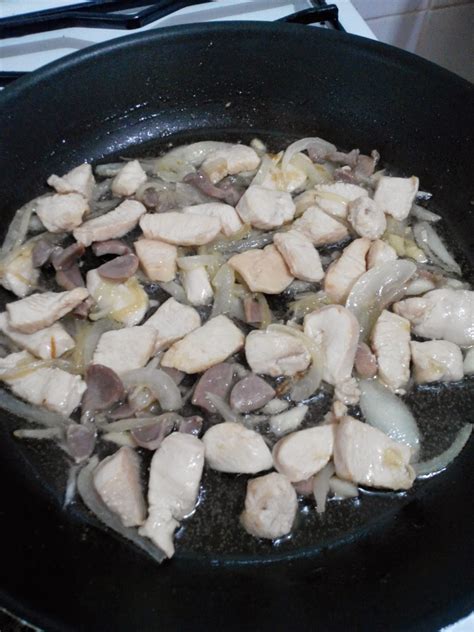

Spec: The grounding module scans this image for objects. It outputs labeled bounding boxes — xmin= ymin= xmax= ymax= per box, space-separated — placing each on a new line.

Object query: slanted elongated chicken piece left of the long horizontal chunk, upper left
xmin=73 ymin=200 xmax=146 ymax=246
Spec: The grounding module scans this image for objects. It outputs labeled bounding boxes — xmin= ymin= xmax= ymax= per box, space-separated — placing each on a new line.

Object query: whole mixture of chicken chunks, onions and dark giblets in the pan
xmin=0 ymin=138 xmax=474 ymax=560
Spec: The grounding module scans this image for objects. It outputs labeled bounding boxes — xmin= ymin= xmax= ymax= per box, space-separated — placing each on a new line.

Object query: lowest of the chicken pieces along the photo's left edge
xmin=6 ymin=362 xmax=86 ymax=417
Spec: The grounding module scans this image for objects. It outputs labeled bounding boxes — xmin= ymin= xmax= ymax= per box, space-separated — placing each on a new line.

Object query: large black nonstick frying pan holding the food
xmin=0 ymin=23 xmax=474 ymax=631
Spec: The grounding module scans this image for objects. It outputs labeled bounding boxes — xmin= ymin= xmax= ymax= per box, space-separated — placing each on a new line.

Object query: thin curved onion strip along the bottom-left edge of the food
xmin=77 ymin=457 xmax=166 ymax=563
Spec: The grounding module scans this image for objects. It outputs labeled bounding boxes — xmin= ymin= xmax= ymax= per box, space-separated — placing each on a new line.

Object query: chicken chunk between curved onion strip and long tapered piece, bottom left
xmin=94 ymin=447 xmax=146 ymax=527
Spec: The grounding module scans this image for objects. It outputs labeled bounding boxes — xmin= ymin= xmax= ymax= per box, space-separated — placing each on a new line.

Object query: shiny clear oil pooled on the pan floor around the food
xmin=1 ymin=130 xmax=474 ymax=563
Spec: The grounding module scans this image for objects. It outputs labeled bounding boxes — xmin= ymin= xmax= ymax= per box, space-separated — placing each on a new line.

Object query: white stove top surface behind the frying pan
xmin=0 ymin=0 xmax=376 ymax=72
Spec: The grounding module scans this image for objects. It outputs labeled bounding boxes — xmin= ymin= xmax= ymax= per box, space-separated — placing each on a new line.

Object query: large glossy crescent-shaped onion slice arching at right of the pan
xmin=346 ymin=259 xmax=417 ymax=342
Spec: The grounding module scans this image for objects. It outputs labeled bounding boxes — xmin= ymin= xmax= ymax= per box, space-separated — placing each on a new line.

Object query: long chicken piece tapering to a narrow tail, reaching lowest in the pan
xmin=140 ymin=432 xmax=204 ymax=557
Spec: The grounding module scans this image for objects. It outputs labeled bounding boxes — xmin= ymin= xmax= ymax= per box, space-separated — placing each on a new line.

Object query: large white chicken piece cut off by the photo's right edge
xmin=393 ymin=288 xmax=474 ymax=347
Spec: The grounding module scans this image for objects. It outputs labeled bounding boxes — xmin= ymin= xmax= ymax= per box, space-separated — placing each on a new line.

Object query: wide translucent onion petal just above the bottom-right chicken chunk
xmin=359 ymin=380 xmax=420 ymax=456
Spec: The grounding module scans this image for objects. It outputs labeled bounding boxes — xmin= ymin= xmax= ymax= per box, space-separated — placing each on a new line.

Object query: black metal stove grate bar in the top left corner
xmin=0 ymin=0 xmax=213 ymax=39
